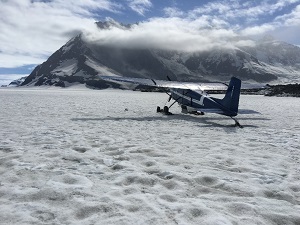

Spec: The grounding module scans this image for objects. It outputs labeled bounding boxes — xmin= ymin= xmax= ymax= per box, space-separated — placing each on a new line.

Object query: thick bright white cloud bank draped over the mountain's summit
xmin=84 ymin=17 xmax=244 ymax=51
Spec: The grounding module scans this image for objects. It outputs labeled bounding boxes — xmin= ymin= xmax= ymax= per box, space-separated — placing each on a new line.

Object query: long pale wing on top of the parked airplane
xmin=99 ymin=76 xmax=228 ymax=91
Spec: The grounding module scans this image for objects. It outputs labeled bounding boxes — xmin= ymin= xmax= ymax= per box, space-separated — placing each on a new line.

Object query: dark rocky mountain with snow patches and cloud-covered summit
xmin=22 ymin=21 xmax=300 ymax=88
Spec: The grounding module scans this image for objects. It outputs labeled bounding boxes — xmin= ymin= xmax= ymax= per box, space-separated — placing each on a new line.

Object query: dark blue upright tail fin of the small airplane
xmin=221 ymin=77 xmax=241 ymax=113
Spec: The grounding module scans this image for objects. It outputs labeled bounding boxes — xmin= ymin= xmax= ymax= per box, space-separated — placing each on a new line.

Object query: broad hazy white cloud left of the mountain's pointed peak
xmin=0 ymin=0 xmax=120 ymax=67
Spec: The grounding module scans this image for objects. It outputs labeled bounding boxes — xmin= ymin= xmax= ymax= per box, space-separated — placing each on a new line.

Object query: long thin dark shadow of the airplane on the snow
xmin=71 ymin=114 xmax=270 ymax=128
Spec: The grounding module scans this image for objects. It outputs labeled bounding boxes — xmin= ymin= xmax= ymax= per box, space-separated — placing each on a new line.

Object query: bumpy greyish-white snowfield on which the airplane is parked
xmin=0 ymin=88 xmax=300 ymax=225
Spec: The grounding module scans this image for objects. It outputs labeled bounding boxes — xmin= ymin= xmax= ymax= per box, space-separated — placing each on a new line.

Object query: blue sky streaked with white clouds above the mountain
xmin=0 ymin=0 xmax=300 ymax=85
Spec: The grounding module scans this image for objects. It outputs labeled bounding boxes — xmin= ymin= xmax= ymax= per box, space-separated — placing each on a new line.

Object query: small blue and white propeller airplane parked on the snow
xmin=99 ymin=76 xmax=257 ymax=128
